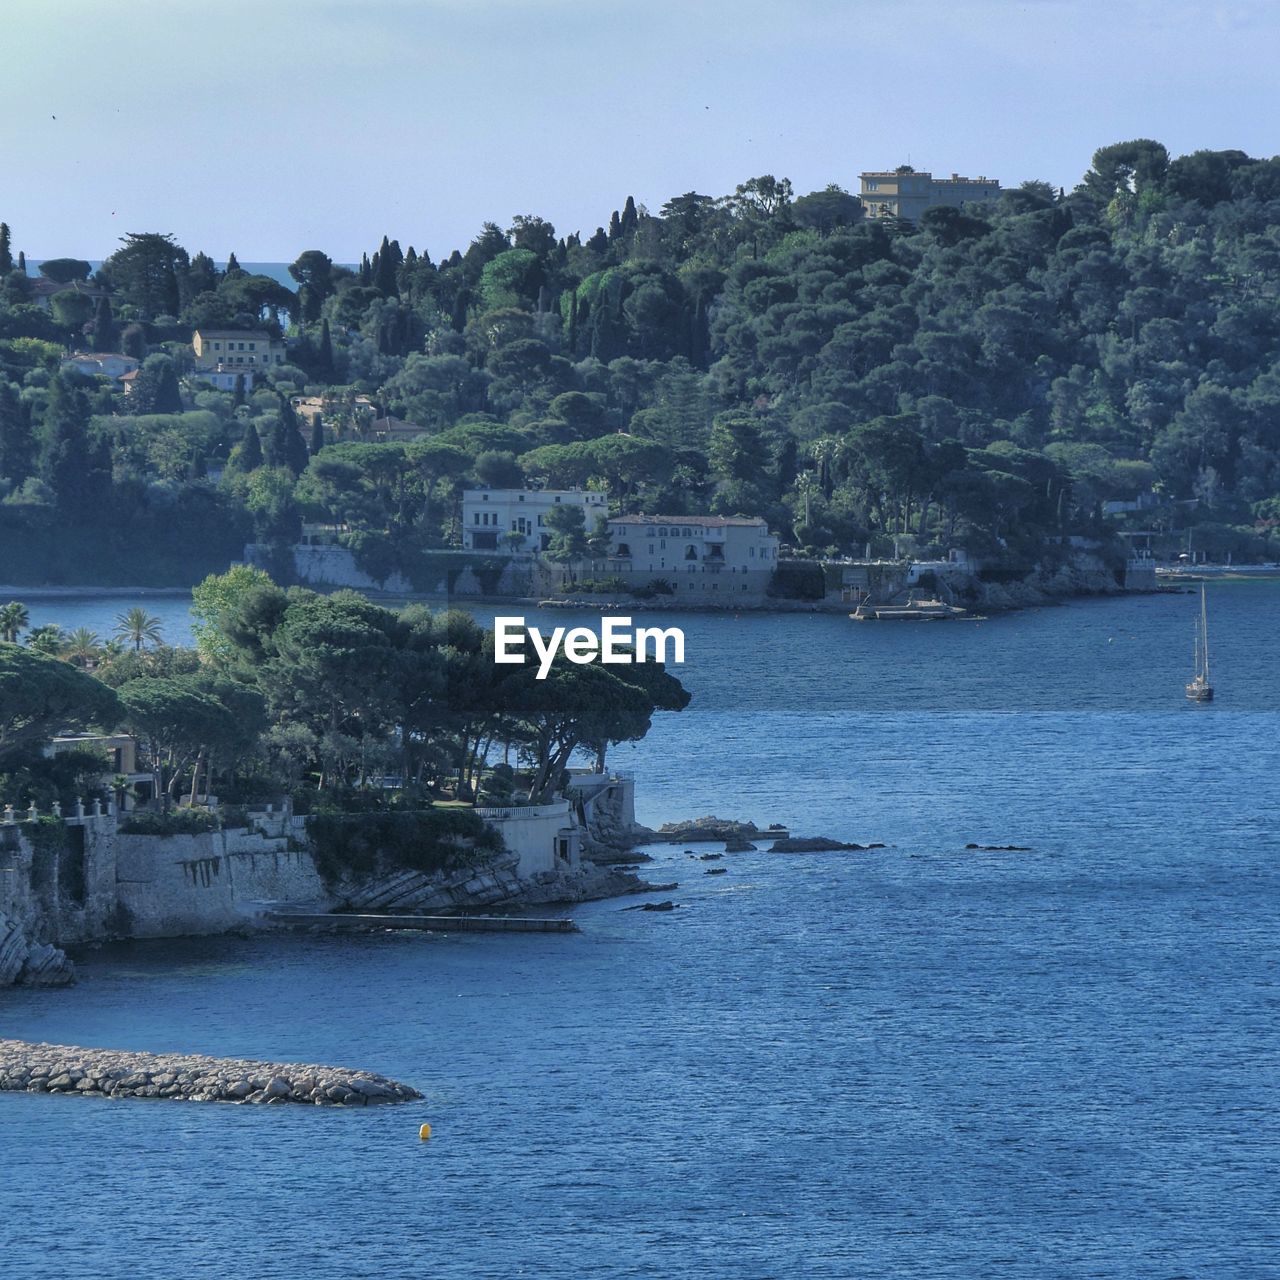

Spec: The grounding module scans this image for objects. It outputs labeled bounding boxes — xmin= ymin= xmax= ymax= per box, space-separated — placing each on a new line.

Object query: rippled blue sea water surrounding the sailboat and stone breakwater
xmin=0 ymin=584 xmax=1280 ymax=1280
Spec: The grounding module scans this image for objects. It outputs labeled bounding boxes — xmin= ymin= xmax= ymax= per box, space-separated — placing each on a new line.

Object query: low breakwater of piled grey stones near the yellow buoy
xmin=0 ymin=1039 xmax=422 ymax=1107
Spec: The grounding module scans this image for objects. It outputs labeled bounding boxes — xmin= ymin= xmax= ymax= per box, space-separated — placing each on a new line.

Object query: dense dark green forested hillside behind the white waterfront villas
xmin=0 ymin=141 xmax=1280 ymax=580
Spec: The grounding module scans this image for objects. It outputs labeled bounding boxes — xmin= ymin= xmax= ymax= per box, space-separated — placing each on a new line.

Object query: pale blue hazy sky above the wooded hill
xmin=0 ymin=0 xmax=1280 ymax=261
